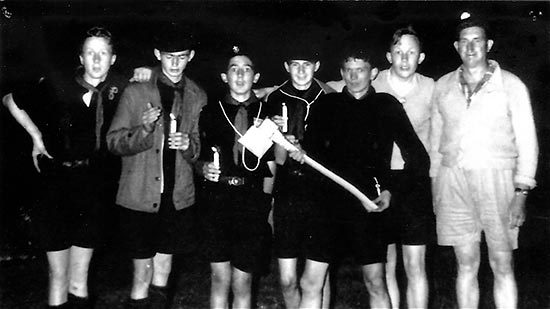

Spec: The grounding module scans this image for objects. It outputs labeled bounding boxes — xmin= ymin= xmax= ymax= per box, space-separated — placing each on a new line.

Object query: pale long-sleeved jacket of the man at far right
xmin=430 ymin=60 xmax=538 ymax=187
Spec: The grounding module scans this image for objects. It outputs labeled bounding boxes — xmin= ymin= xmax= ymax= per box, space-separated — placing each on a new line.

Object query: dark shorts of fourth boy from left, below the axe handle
xmin=273 ymin=167 xmax=322 ymax=258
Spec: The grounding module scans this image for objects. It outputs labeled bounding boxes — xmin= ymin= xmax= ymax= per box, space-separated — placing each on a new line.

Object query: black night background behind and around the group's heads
xmin=0 ymin=0 xmax=550 ymax=307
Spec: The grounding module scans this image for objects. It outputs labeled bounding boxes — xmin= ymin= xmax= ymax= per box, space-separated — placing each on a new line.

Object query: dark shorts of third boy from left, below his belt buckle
xmin=203 ymin=183 xmax=271 ymax=273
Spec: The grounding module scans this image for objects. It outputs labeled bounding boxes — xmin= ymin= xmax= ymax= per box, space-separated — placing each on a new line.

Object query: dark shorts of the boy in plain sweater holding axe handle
xmin=306 ymin=199 xmax=387 ymax=265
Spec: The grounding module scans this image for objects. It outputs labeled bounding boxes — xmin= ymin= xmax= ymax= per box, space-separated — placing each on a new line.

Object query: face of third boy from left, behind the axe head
xmin=221 ymin=55 xmax=260 ymax=95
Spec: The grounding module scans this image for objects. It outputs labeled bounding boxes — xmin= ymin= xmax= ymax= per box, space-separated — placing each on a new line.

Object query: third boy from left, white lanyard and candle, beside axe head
xmin=196 ymin=46 xmax=273 ymax=308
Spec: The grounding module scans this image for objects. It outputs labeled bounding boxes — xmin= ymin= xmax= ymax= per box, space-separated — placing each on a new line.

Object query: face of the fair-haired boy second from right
xmin=386 ymin=34 xmax=426 ymax=79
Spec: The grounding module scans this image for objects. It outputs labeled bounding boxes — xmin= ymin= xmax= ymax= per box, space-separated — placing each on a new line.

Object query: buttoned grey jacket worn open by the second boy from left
xmin=107 ymin=69 xmax=206 ymax=212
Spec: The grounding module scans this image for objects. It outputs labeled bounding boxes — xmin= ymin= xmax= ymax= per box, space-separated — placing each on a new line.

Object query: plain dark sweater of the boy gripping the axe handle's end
xmin=303 ymin=87 xmax=430 ymax=203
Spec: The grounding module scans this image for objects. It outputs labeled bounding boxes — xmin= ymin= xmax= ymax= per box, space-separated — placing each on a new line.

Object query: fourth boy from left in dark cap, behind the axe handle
xmin=267 ymin=45 xmax=333 ymax=308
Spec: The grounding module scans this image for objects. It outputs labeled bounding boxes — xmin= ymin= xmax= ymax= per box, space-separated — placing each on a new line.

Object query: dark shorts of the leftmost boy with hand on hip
xmin=31 ymin=167 xmax=110 ymax=251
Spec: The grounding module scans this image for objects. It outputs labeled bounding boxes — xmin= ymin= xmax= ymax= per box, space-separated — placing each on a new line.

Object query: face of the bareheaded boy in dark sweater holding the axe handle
xmin=340 ymin=58 xmax=378 ymax=99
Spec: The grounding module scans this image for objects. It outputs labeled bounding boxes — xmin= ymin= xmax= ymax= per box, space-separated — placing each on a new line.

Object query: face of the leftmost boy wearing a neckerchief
xmin=79 ymin=36 xmax=116 ymax=85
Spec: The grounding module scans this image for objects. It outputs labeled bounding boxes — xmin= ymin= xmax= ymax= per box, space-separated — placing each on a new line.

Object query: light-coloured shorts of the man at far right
xmin=434 ymin=166 xmax=519 ymax=251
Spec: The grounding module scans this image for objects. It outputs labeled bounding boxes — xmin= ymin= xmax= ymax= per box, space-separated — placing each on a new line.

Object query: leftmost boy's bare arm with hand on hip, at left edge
xmin=2 ymin=93 xmax=52 ymax=172
